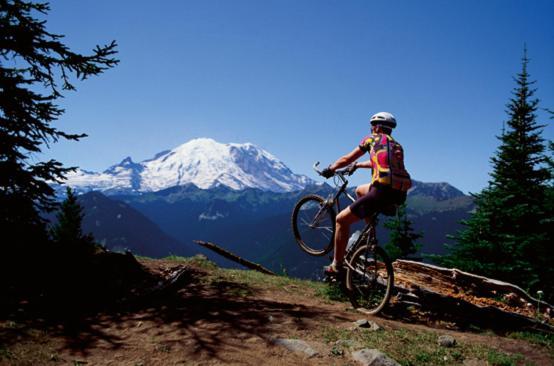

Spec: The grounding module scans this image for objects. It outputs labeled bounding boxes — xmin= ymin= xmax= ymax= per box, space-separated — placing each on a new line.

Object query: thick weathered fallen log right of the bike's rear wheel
xmin=393 ymin=260 xmax=554 ymax=333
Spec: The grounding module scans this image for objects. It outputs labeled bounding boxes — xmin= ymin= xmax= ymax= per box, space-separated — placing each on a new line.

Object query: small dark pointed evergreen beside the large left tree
xmin=51 ymin=187 xmax=94 ymax=246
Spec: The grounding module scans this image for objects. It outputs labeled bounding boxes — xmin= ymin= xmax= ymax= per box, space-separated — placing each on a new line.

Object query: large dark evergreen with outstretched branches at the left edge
xmin=0 ymin=0 xmax=118 ymax=242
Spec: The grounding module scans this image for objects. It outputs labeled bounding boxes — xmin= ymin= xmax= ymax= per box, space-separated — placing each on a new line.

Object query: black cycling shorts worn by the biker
xmin=350 ymin=185 xmax=406 ymax=219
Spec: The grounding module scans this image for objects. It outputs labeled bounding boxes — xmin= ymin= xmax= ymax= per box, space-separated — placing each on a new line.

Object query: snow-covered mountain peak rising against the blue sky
xmin=62 ymin=138 xmax=315 ymax=193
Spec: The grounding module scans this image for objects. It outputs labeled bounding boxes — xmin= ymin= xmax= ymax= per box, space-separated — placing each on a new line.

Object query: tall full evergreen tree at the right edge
xmin=440 ymin=50 xmax=554 ymax=298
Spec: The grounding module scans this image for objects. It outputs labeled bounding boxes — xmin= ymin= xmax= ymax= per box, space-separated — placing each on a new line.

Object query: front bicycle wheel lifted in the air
xmin=292 ymin=195 xmax=335 ymax=256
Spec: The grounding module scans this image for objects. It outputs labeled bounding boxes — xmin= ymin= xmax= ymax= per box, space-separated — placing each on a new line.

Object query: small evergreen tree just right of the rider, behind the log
xmin=385 ymin=204 xmax=423 ymax=260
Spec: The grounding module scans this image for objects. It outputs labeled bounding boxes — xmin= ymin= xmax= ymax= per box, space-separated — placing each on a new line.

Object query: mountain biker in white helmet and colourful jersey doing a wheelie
xmin=321 ymin=112 xmax=411 ymax=275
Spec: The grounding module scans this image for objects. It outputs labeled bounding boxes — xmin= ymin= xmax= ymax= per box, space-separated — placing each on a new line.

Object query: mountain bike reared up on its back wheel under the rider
xmin=292 ymin=162 xmax=398 ymax=314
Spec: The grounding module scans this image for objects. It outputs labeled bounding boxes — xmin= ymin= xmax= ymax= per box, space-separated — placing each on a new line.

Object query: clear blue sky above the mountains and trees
xmin=40 ymin=0 xmax=554 ymax=192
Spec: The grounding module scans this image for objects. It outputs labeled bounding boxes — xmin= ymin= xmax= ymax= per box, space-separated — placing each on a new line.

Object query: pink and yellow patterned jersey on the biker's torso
xmin=360 ymin=133 xmax=412 ymax=192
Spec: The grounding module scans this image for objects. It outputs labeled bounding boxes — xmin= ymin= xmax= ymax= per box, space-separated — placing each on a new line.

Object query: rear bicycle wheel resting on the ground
xmin=346 ymin=245 xmax=394 ymax=315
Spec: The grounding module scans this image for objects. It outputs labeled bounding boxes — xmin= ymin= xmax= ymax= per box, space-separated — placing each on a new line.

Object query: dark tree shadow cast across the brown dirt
xmin=0 ymin=266 xmax=344 ymax=361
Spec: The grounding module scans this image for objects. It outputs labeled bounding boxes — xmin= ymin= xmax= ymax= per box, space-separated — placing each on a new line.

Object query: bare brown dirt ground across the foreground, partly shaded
xmin=0 ymin=260 xmax=554 ymax=365
